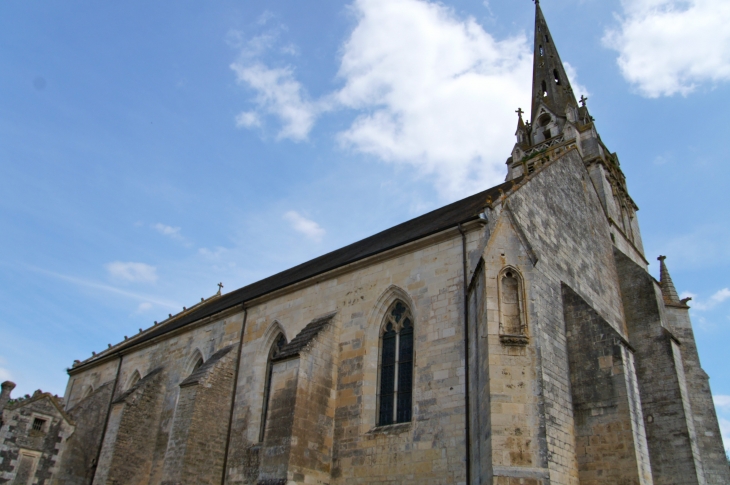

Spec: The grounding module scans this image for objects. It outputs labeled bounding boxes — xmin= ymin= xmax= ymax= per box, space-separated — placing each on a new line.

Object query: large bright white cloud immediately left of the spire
xmin=337 ymin=0 xmax=532 ymax=198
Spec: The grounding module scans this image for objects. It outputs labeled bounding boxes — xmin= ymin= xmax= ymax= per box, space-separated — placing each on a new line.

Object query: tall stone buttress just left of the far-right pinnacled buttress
xmin=615 ymin=250 xmax=706 ymax=485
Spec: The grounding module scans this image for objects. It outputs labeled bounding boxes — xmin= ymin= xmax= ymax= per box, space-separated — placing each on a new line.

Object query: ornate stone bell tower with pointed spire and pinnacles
xmin=506 ymin=0 xmax=648 ymax=258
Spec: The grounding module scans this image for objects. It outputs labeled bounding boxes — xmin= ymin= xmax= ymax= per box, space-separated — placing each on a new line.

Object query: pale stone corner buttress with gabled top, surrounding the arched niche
xmin=469 ymin=214 xmax=550 ymax=485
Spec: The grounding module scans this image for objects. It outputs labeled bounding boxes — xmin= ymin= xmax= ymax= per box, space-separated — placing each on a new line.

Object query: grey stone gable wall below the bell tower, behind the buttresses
xmin=494 ymin=150 xmax=626 ymax=484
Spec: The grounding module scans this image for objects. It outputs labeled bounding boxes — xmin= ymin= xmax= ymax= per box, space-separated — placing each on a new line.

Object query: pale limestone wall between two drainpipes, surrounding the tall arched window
xmin=227 ymin=228 xmax=478 ymax=485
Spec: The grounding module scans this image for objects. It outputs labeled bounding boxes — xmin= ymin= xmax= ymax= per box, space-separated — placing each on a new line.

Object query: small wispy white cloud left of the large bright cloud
xmin=231 ymin=61 xmax=318 ymax=141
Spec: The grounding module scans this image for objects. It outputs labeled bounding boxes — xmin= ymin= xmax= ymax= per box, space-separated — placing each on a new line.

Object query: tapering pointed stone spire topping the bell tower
xmin=531 ymin=0 xmax=578 ymax=126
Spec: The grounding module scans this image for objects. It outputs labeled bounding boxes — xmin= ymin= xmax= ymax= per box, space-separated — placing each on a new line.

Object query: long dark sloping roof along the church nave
xmin=74 ymin=177 xmax=522 ymax=369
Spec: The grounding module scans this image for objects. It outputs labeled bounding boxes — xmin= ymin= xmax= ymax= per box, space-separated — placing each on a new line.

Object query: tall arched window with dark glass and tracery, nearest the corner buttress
xmin=378 ymin=300 xmax=413 ymax=426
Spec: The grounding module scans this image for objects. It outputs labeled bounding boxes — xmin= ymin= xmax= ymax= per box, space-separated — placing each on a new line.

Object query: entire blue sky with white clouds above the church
xmin=0 ymin=0 xmax=730 ymax=452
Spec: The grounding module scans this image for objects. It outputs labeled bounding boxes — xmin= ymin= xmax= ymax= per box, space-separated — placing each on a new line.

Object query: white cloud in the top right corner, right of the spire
xmin=603 ymin=0 xmax=730 ymax=98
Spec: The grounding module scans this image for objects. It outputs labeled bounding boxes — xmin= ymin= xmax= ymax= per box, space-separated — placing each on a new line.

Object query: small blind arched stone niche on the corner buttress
xmin=499 ymin=268 xmax=527 ymax=345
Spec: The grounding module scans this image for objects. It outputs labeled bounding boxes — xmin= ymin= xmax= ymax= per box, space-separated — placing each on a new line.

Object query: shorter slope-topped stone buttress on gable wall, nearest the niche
xmin=563 ymin=286 xmax=652 ymax=485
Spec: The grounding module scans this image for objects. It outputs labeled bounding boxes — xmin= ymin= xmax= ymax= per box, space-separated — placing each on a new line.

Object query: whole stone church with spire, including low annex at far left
xmin=0 ymin=2 xmax=730 ymax=485
